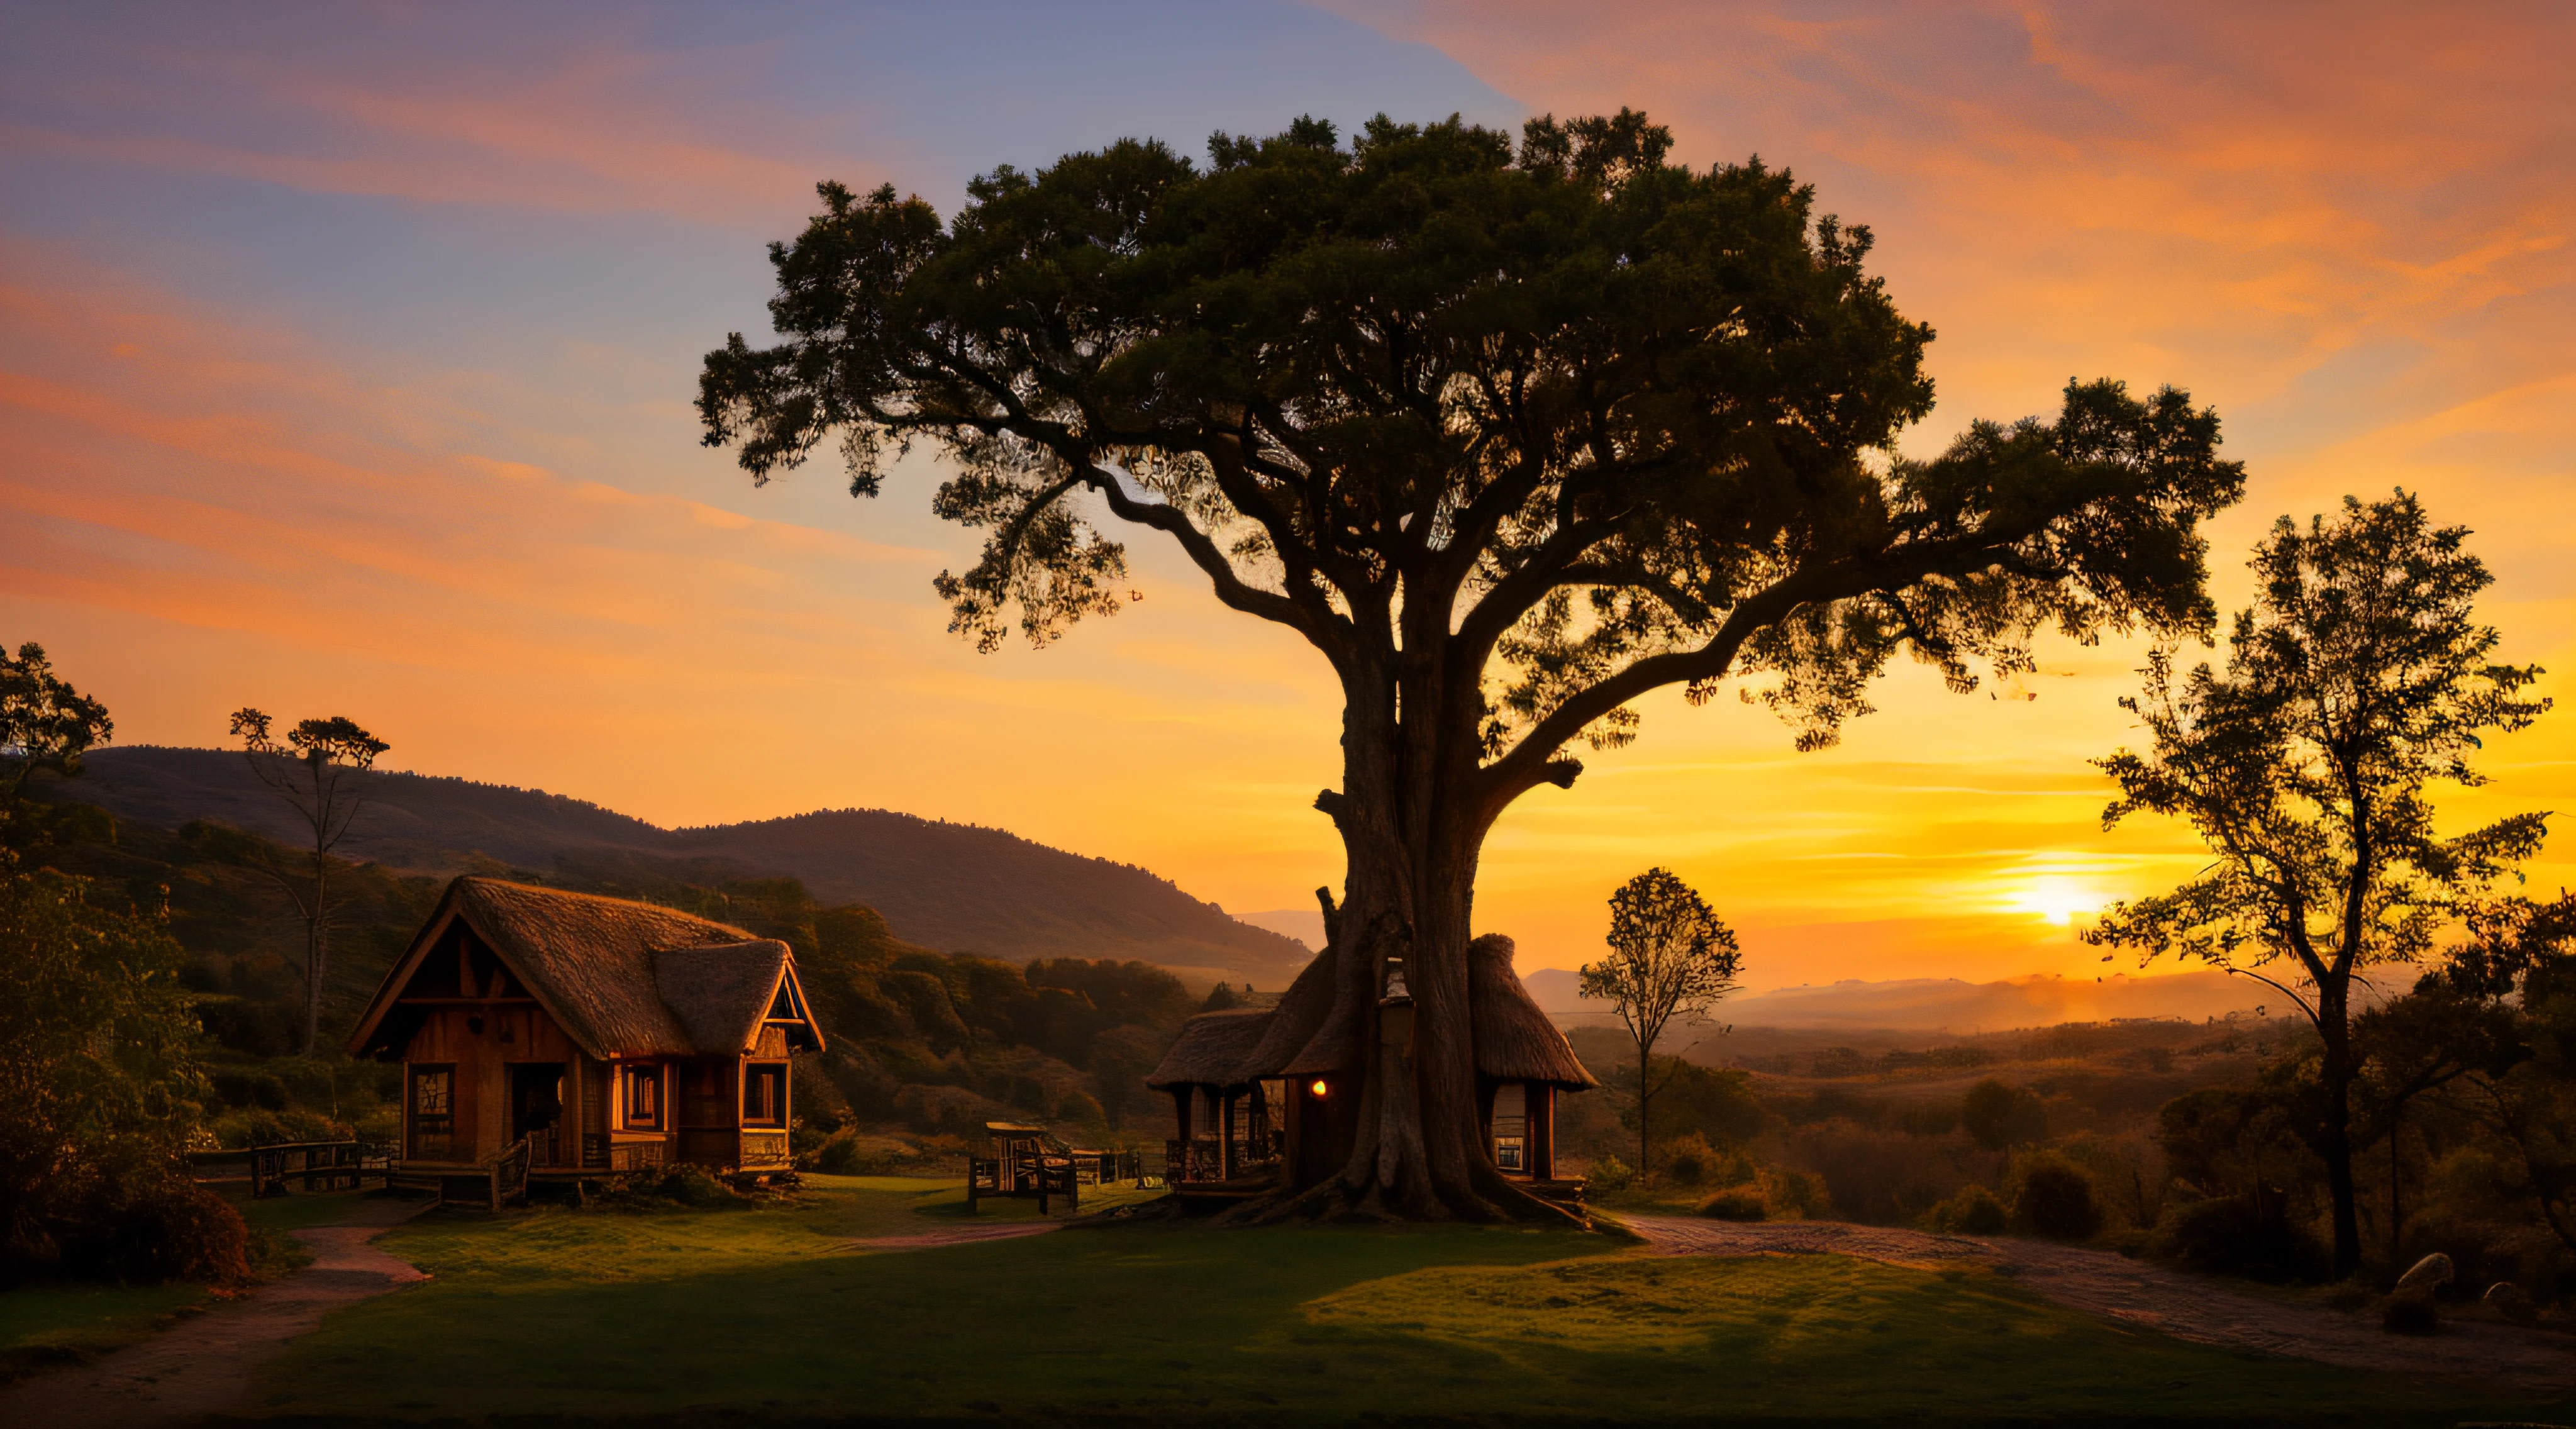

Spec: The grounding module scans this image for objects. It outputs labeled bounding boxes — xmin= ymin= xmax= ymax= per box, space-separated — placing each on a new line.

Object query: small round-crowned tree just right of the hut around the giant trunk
xmin=1579 ymin=868 xmax=1741 ymax=1177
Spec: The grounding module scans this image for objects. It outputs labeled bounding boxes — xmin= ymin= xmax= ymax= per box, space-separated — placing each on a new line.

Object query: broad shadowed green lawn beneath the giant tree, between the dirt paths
xmin=246 ymin=1177 xmax=2550 ymax=1424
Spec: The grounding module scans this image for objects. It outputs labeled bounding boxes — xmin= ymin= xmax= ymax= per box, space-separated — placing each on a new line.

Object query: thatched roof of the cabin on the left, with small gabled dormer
xmin=350 ymin=878 xmax=822 ymax=1061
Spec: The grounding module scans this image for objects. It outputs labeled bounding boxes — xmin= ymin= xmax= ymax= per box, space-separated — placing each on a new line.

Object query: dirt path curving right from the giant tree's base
xmin=1623 ymin=1215 xmax=2576 ymax=1388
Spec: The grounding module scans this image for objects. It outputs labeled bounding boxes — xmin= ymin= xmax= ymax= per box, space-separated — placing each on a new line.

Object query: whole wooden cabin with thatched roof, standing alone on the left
xmin=348 ymin=878 xmax=824 ymax=1182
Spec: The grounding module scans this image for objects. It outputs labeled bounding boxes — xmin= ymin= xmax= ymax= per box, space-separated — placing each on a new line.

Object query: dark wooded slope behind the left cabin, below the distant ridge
xmin=21 ymin=803 xmax=1198 ymax=1164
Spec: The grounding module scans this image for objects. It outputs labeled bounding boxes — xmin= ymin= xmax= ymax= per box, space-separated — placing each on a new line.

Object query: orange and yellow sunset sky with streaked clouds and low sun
xmin=0 ymin=0 xmax=2576 ymax=986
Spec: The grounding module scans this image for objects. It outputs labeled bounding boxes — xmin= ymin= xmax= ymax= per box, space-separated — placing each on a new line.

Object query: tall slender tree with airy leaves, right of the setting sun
xmin=2087 ymin=492 xmax=2548 ymax=1277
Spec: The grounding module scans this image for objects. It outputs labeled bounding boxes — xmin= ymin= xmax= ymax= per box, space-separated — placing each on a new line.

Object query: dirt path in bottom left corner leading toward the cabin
xmin=0 ymin=1198 xmax=428 ymax=1429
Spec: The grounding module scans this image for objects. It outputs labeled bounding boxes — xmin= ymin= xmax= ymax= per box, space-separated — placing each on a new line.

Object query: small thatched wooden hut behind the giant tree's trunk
xmin=1146 ymin=935 xmax=1600 ymax=1194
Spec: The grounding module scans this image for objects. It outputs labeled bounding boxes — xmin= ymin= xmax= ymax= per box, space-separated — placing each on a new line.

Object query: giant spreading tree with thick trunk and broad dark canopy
xmin=698 ymin=111 xmax=2244 ymax=1215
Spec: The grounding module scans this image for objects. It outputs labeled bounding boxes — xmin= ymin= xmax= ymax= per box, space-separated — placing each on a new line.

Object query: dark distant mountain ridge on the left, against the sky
xmin=42 ymin=744 xmax=1311 ymax=989
